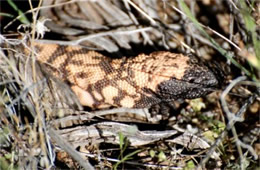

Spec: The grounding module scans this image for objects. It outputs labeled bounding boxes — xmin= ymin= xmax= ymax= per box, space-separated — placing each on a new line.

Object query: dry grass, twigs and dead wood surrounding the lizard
xmin=0 ymin=0 xmax=260 ymax=169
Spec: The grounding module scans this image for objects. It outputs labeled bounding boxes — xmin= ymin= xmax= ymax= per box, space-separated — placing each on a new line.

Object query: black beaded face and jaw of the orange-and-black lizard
xmin=158 ymin=55 xmax=221 ymax=100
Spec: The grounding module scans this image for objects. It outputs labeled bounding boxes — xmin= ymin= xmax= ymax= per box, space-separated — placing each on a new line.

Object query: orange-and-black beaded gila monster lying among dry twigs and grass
xmin=25 ymin=43 xmax=219 ymax=109
